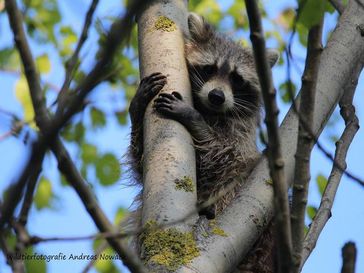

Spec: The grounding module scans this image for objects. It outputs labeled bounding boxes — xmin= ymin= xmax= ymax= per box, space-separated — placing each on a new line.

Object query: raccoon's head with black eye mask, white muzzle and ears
xmin=185 ymin=13 xmax=278 ymax=117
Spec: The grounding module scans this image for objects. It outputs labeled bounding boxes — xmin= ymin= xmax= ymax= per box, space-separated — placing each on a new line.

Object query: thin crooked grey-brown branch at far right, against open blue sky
xmin=301 ymin=67 xmax=360 ymax=267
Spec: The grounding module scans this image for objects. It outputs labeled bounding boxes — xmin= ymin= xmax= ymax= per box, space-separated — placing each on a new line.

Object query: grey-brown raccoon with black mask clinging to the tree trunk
xmin=130 ymin=13 xmax=278 ymax=272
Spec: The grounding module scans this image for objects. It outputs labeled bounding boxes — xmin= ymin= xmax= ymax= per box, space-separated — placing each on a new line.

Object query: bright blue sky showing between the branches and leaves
xmin=0 ymin=0 xmax=364 ymax=273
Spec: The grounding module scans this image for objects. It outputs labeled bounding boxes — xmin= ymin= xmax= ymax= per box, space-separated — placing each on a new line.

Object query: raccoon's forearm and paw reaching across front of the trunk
xmin=154 ymin=92 xmax=211 ymax=140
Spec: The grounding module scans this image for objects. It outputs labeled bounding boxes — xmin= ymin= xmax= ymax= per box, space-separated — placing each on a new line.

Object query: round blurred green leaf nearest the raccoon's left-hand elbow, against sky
xmin=96 ymin=153 xmax=121 ymax=186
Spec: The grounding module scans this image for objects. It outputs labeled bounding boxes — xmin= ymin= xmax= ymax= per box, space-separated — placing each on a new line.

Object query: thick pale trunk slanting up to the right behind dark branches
xmin=177 ymin=0 xmax=364 ymax=273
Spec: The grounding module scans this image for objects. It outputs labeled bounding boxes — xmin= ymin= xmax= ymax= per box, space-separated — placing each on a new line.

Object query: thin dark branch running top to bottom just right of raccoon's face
xmin=245 ymin=0 xmax=292 ymax=272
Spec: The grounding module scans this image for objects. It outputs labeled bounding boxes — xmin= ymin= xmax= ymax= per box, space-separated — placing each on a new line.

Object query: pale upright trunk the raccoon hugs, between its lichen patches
xmin=138 ymin=0 xmax=197 ymax=232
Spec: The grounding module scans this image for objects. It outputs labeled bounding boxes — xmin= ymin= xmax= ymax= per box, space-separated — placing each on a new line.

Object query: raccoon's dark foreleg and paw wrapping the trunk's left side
xmin=129 ymin=72 xmax=167 ymax=170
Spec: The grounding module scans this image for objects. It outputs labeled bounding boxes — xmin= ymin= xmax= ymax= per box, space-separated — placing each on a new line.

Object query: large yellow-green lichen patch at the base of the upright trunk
xmin=141 ymin=221 xmax=200 ymax=271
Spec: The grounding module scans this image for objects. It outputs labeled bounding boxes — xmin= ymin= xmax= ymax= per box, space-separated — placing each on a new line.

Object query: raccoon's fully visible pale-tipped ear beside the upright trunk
xmin=188 ymin=12 xmax=214 ymax=43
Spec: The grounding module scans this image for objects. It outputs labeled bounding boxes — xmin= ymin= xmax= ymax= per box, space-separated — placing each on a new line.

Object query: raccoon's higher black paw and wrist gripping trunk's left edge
xmin=129 ymin=72 xmax=167 ymax=124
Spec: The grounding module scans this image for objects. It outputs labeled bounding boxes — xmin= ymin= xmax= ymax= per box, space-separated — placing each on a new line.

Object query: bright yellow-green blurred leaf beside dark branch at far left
xmin=15 ymin=76 xmax=35 ymax=127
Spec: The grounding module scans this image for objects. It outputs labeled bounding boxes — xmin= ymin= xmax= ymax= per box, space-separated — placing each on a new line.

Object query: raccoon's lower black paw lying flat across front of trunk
xmin=154 ymin=92 xmax=194 ymax=122
